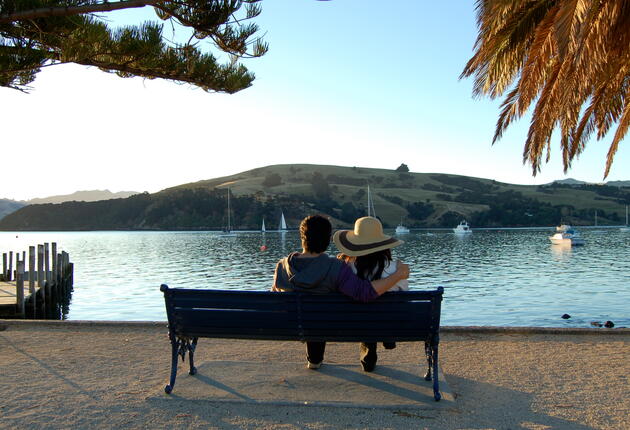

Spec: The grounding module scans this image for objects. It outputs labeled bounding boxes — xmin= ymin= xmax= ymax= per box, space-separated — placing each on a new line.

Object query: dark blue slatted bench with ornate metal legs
xmin=160 ymin=285 xmax=444 ymax=401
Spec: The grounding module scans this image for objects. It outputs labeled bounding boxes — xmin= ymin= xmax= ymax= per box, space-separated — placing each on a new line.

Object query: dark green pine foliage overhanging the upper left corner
xmin=0 ymin=0 xmax=267 ymax=93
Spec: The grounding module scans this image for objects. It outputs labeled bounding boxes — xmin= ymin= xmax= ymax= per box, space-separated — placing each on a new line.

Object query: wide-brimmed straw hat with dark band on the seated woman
xmin=333 ymin=216 xmax=404 ymax=257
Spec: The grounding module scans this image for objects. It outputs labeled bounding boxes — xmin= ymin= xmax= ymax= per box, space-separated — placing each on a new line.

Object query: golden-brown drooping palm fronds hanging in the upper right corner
xmin=461 ymin=0 xmax=630 ymax=177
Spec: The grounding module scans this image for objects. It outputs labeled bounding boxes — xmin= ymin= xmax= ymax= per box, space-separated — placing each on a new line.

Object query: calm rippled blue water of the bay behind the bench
xmin=0 ymin=228 xmax=630 ymax=327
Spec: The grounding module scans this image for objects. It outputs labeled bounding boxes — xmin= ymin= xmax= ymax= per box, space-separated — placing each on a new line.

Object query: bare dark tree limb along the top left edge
xmin=0 ymin=0 xmax=163 ymax=24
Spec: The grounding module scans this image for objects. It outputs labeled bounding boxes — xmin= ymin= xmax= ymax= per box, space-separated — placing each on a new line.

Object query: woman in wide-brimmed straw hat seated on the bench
xmin=333 ymin=217 xmax=409 ymax=372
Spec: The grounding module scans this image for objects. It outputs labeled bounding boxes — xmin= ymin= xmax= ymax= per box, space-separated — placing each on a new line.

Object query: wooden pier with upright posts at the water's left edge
xmin=0 ymin=242 xmax=74 ymax=319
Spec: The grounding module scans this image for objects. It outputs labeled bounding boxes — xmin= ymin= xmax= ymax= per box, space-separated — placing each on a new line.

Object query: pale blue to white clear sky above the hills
xmin=0 ymin=0 xmax=630 ymax=200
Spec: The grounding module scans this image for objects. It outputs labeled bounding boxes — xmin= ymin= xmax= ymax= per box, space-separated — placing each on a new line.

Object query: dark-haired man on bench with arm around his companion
xmin=271 ymin=215 xmax=409 ymax=369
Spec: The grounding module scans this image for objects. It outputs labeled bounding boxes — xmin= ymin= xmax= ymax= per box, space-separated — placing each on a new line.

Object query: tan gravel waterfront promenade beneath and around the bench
xmin=0 ymin=320 xmax=630 ymax=430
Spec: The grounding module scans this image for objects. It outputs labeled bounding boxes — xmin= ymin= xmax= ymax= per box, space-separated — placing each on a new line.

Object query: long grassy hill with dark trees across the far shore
xmin=0 ymin=164 xmax=630 ymax=230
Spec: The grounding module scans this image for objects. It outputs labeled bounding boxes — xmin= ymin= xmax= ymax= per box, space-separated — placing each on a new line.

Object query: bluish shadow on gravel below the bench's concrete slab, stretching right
xmin=146 ymin=375 xmax=600 ymax=430
